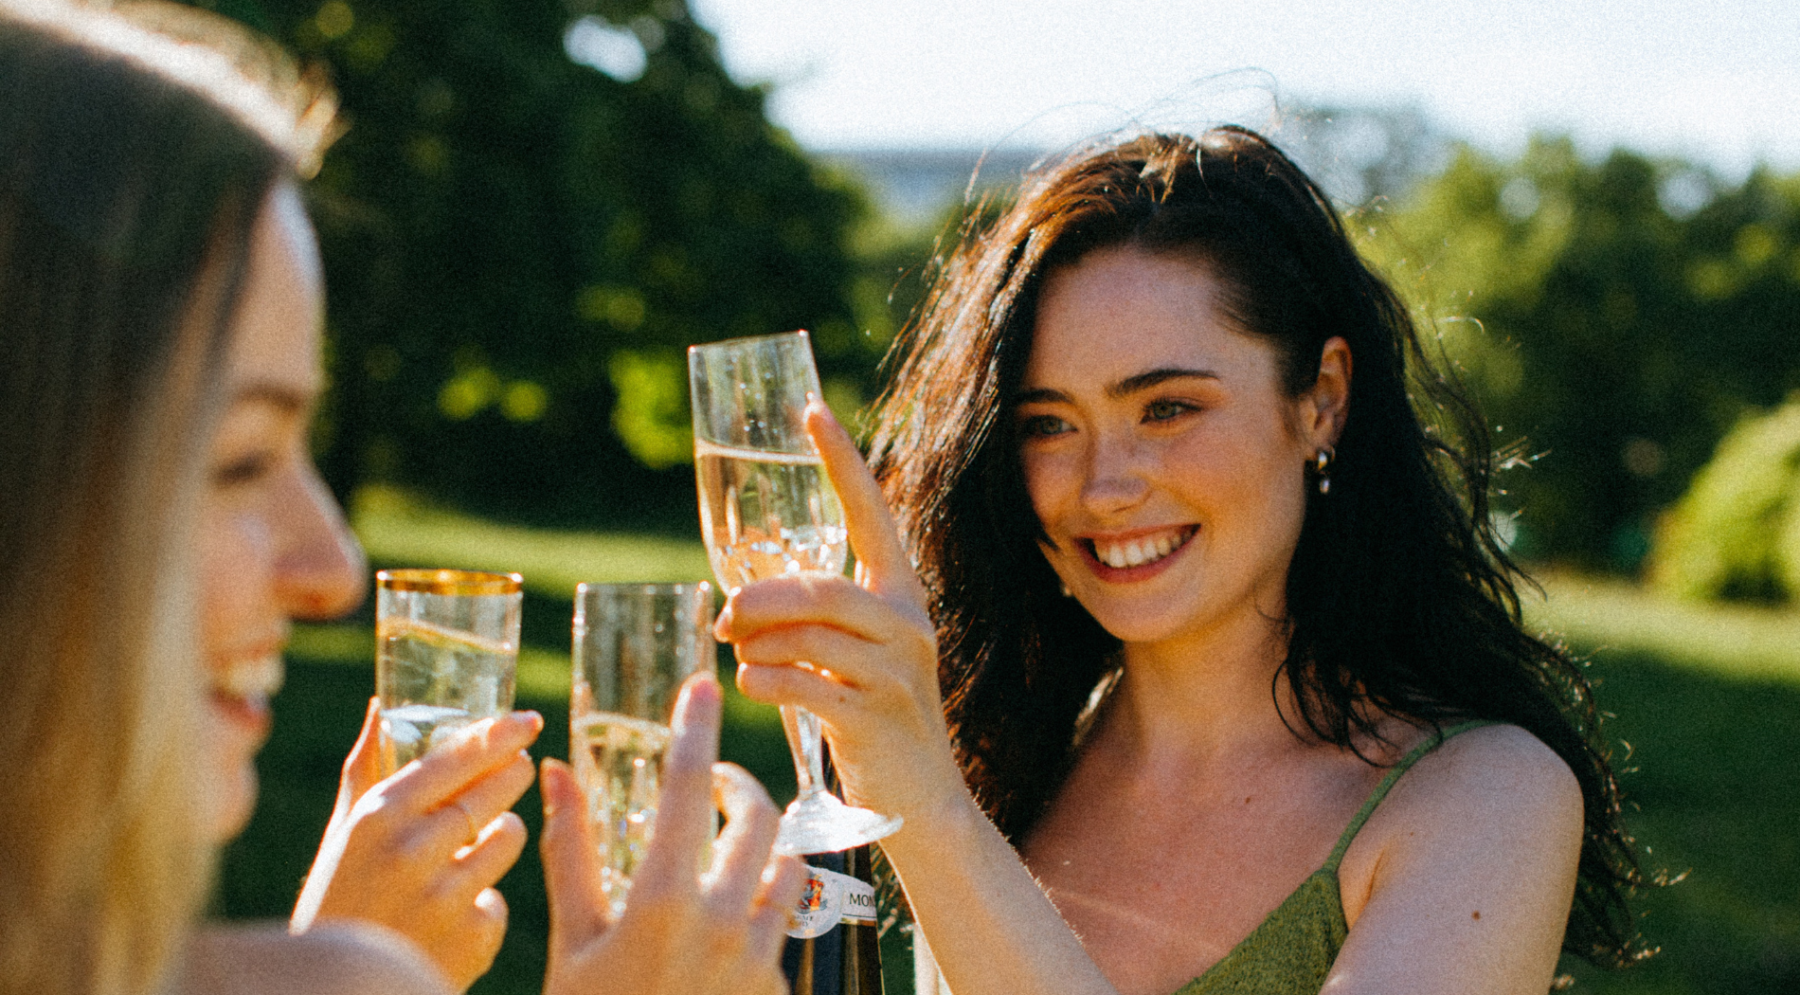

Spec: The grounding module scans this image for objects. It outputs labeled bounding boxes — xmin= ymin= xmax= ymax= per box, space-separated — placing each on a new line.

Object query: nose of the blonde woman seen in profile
xmin=275 ymin=466 xmax=369 ymax=619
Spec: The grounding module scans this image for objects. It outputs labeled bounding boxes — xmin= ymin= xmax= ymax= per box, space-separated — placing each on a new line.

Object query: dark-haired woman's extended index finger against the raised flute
xmin=806 ymin=399 xmax=925 ymax=610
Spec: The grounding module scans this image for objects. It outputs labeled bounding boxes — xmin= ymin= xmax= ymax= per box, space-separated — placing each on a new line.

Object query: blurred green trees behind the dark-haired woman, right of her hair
xmin=1370 ymin=137 xmax=1800 ymax=572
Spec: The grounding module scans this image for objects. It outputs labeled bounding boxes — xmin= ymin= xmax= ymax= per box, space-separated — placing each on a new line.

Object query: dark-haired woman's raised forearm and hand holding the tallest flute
xmin=716 ymin=403 xmax=1112 ymax=995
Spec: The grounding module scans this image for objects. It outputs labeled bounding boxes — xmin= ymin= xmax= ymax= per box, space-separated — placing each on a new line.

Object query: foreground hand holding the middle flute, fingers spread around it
xmin=540 ymin=673 xmax=806 ymax=995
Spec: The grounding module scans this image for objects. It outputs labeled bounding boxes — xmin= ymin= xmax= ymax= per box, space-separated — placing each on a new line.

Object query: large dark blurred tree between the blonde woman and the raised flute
xmin=184 ymin=0 xmax=886 ymax=525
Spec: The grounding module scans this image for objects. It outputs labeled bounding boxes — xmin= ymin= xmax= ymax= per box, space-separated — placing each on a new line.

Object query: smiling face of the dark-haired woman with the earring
xmin=1015 ymin=248 xmax=1346 ymax=644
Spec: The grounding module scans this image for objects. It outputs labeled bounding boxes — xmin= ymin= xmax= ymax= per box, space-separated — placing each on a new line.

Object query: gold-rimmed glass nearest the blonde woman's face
xmin=374 ymin=570 xmax=524 ymax=777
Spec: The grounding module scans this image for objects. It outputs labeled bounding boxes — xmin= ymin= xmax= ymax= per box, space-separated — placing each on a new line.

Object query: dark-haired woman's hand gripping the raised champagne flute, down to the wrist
xmin=715 ymin=401 xmax=970 ymax=833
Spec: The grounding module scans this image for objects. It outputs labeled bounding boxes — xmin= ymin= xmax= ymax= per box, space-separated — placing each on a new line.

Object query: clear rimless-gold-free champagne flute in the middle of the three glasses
xmin=569 ymin=581 xmax=718 ymax=916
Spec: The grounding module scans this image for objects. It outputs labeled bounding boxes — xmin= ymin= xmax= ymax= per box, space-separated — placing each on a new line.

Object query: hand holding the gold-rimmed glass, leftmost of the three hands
xmin=290 ymin=702 xmax=544 ymax=991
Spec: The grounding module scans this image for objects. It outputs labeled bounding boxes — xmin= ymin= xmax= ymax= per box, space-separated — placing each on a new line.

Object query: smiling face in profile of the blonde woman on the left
xmin=200 ymin=184 xmax=364 ymax=842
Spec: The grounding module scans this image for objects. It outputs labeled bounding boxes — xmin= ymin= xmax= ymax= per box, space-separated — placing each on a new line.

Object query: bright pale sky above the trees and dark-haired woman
xmin=689 ymin=0 xmax=1800 ymax=175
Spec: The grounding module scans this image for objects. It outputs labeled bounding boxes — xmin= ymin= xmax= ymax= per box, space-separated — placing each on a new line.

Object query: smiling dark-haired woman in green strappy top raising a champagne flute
xmin=720 ymin=128 xmax=1640 ymax=995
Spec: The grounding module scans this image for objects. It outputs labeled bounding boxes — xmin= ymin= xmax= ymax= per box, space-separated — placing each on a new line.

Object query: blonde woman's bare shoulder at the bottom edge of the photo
xmin=182 ymin=923 xmax=450 ymax=995
